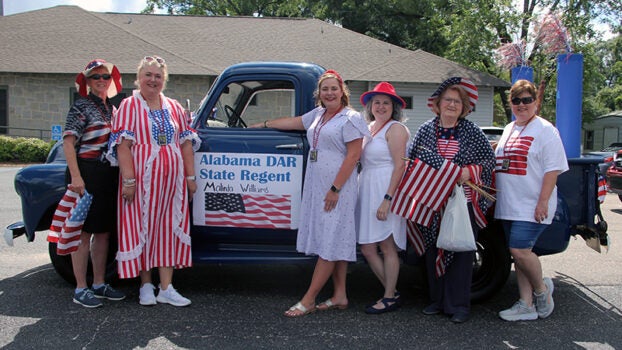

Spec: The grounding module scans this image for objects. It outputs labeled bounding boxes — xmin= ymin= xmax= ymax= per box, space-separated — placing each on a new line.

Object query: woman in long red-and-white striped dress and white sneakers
xmin=109 ymin=56 xmax=200 ymax=306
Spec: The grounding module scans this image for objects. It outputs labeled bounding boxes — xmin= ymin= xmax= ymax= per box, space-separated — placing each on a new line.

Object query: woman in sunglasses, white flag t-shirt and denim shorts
xmin=495 ymin=79 xmax=568 ymax=321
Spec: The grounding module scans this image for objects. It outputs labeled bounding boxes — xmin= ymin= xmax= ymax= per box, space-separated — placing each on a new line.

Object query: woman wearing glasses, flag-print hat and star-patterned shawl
xmin=409 ymin=77 xmax=495 ymax=323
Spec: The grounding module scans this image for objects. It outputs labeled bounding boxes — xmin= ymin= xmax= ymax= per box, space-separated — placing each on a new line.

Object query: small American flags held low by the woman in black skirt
xmin=53 ymin=190 xmax=93 ymax=255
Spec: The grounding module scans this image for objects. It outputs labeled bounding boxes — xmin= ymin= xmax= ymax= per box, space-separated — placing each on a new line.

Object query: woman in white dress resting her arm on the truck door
xmin=251 ymin=70 xmax=369 ymax=317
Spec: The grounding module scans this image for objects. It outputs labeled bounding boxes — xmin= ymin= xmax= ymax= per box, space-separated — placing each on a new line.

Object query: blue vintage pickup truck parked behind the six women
xmin=7 ymin=62 xmax=608 ymax=301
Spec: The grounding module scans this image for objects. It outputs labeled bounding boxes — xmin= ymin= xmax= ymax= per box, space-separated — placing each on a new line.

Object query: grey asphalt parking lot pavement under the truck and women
xmin=0 ymin=169 xmax=622 ymax=349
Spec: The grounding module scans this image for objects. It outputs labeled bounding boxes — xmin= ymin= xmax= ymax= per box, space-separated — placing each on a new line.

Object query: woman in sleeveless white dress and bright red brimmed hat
xmin=357 ymin=82 xmax=410 ymax=314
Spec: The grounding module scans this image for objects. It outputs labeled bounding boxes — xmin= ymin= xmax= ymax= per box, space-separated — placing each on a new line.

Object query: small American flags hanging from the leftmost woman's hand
xmin=48 ymin=190 xmax=93 ymax=255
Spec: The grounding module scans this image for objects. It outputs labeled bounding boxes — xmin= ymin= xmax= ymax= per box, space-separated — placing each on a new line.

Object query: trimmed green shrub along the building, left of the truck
xmin=0 ymin=136 xmax=54 ymax=163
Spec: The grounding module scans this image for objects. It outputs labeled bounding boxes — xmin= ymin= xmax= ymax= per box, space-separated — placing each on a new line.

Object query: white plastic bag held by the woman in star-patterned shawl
xmin=436 ymin=185 xmax=476 ymax=252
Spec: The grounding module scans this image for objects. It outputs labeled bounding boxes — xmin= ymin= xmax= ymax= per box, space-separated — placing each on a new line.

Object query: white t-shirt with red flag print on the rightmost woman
xmin=495 ymin=117 xmax=568 ymax=224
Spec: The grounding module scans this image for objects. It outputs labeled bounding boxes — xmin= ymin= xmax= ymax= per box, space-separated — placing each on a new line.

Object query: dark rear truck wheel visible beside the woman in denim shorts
xmin=471 ymin=221 xmax=512 ymax=303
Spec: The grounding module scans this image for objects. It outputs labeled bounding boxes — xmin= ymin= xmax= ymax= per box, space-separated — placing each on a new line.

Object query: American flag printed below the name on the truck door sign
xmin=205 ymin=192 xmax=291 ymax=229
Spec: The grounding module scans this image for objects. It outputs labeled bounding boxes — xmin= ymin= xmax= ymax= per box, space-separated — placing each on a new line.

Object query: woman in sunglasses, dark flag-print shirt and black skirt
xmin=63 ymin=59 xmax=125 ymax=308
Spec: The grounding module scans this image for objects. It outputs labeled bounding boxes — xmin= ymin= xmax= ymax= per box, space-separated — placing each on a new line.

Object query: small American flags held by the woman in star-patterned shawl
xmin=391 ymin=155 xmax=461 ymax=226
